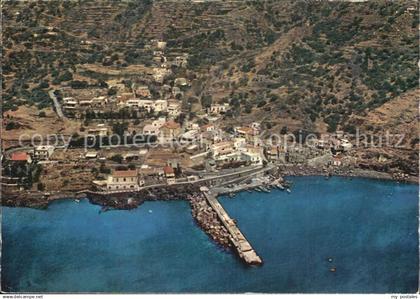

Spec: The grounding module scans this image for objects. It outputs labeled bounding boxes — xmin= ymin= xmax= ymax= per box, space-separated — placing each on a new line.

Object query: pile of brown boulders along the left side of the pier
xmin=188 ymin=193 xmax=231 ymax=248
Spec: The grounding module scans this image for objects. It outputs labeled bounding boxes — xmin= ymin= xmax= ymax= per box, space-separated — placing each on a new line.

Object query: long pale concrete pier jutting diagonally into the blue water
xmin=203 ymin=191 xmax=262 ymax=265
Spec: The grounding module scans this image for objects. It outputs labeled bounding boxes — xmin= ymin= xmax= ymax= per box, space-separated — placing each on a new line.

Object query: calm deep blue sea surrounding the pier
xmin=2 ymin=177 xmax=419 ymax=293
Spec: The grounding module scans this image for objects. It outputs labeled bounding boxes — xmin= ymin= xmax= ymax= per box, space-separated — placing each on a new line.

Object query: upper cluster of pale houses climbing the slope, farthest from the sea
xmin=62 ymin=40 xmax=190 ymax=118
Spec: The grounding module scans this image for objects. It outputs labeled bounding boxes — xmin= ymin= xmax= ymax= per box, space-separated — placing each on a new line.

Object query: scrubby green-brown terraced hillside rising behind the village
xmin=2 ymin=0 xmax=419 ymax=144
